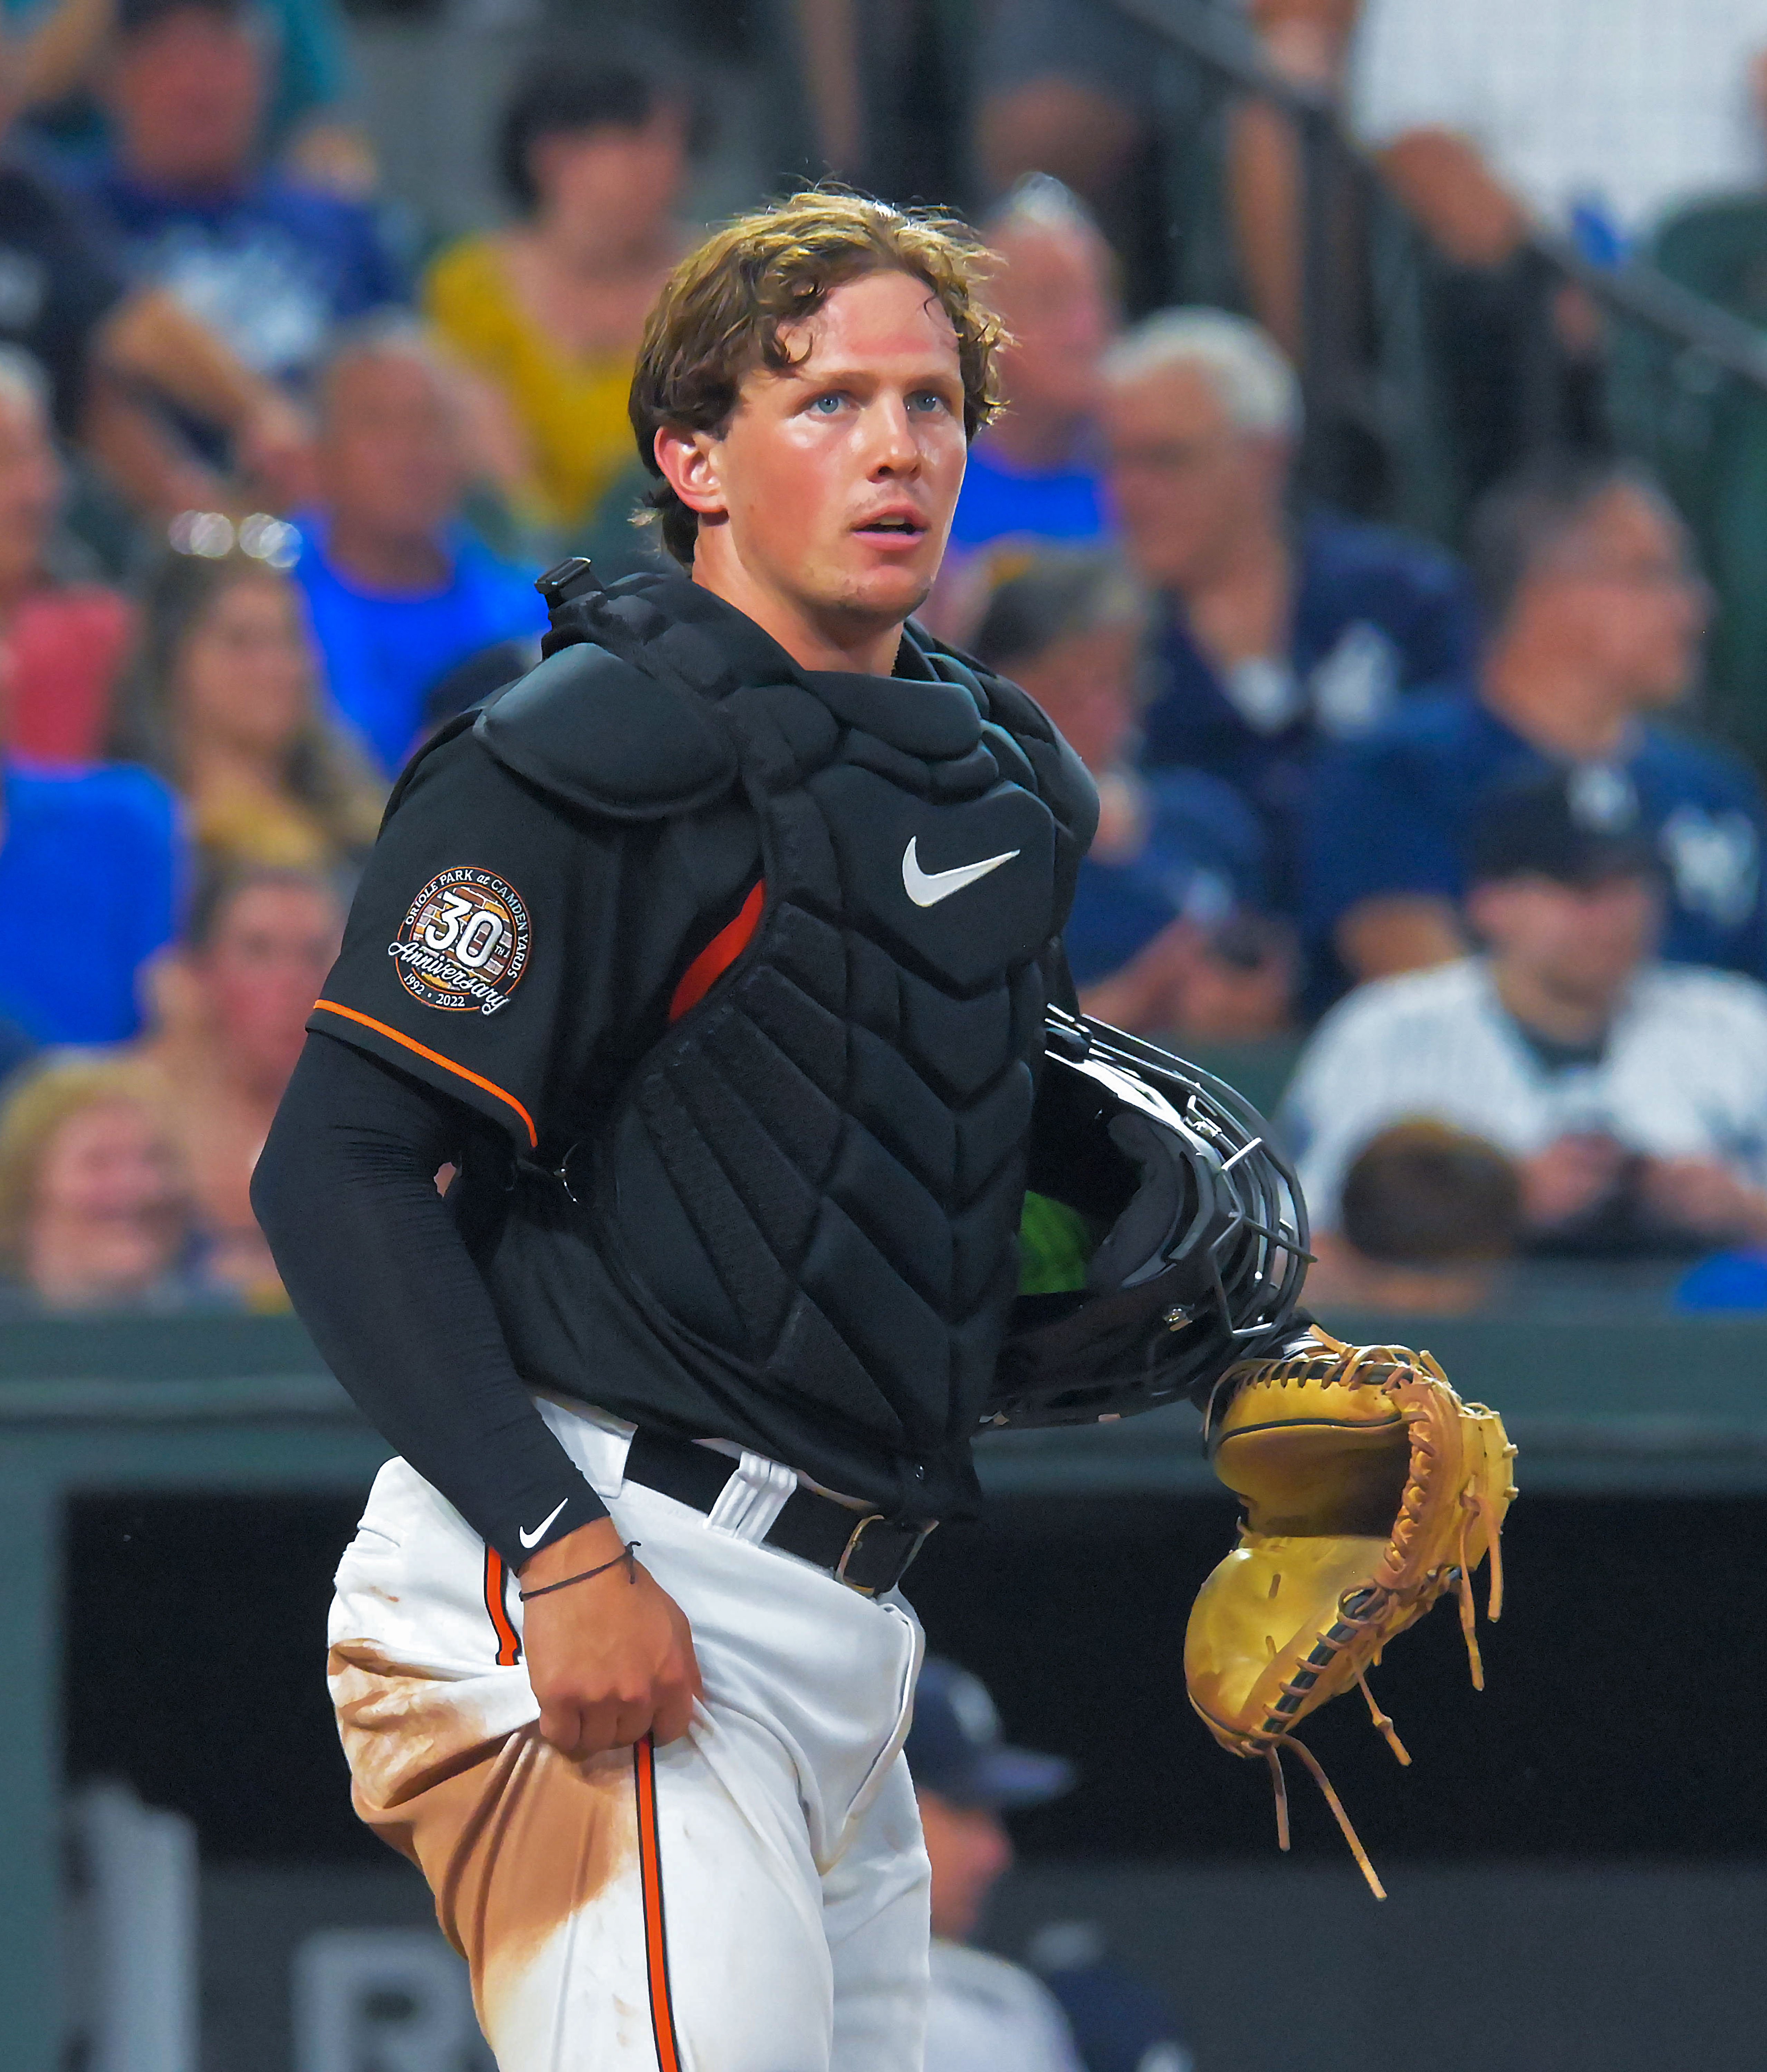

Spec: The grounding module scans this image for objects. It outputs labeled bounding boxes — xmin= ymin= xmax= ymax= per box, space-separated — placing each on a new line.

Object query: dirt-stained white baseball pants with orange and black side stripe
xmin=329 ymin=1403 xmax=928 ymax=2072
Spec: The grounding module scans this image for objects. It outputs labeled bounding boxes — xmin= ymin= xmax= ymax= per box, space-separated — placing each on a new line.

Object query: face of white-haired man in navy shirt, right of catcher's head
xmin=1104 ymin=365 xmax=1288 ymax=595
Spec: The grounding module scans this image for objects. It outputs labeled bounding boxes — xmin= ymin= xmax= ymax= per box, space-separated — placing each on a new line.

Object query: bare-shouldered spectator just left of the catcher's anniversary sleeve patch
xmin=135 ymin=868 xmax=344 ymax=1305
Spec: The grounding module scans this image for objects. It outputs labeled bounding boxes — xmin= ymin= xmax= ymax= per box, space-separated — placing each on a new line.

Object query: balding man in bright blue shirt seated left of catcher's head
xmin=294 ymin=319 xmax=547 ymax=775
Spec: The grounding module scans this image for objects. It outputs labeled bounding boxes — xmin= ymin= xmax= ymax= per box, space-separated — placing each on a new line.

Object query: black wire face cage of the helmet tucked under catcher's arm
xmin=986 ymin=1009 xmax=1309 ymax=1426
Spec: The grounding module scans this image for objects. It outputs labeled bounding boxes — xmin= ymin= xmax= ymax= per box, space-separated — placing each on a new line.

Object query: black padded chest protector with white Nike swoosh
xmin=479 ymin=578 xmax=1096 ymax=1465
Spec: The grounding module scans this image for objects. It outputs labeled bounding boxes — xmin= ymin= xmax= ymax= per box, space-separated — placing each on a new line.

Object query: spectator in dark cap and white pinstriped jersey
xmin=1286 ymin=775 xmax=1767 ymax=1251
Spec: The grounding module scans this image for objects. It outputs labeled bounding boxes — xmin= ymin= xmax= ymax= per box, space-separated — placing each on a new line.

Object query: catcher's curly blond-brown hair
xmin=630 ymin=186 xmax=1005 ymax=568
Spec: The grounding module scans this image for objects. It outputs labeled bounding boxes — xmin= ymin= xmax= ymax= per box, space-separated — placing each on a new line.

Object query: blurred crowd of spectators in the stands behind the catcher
xmin=0 ymin=0 xmax=1767 ymax=1312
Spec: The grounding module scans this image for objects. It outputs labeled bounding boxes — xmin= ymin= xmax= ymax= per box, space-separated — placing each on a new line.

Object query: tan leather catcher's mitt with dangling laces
xmin=1185 ymin=1326 xmax=1516 ymax=1898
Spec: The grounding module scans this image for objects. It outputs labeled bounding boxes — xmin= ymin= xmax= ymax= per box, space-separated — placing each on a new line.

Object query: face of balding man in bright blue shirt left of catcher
xmin=319 ymin=352 xmax=468 ymax=539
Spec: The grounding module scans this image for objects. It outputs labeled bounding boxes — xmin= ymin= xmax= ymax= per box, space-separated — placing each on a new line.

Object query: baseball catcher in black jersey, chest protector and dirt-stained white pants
xmin=255 ymin=195 xmax=1475 ymax=2072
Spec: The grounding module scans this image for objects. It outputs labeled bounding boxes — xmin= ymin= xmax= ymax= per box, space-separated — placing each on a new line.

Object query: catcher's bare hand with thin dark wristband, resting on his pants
xmin=522 ymin=1519 xmax=700 ymax=1757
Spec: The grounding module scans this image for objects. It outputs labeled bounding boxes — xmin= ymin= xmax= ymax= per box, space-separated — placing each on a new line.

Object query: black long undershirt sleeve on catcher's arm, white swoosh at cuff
xmin=253 ymin=1034 xmax=607 ymax=1566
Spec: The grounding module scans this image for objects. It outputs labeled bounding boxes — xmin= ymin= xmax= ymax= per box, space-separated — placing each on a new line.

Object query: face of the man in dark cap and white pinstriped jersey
xmin=1467 ymin=876 xmax=1661 ymax=1009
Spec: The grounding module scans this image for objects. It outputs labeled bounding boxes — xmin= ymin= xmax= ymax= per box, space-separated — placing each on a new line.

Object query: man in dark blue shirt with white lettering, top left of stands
xmin=75 ymin=0 xmax=404 ymax=400
